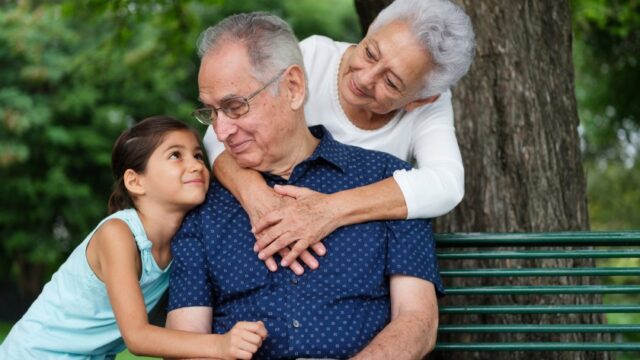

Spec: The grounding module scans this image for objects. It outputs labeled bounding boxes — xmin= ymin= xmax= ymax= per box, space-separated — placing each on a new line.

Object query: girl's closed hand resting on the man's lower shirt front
xmin=222 ymin=321 xmax=267 ymax=359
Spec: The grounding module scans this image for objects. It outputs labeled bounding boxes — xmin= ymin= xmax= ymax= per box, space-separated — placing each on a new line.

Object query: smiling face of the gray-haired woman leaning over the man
xmin=339 ymin=21 xmax=431 ymax=114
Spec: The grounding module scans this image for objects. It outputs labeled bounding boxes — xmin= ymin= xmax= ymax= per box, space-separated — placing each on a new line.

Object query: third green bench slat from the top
xmin=440 ymin=268 xmax=640 ymax=277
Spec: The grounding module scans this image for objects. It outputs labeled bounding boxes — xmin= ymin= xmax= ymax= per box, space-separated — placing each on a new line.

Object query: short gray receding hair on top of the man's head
xmin=198 ymin=12 xmax=306 ymax=93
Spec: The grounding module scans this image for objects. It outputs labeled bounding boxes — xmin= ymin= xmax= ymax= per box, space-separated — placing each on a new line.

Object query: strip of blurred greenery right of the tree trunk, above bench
xmin=571 ymin=0 xmax=640 ymax=230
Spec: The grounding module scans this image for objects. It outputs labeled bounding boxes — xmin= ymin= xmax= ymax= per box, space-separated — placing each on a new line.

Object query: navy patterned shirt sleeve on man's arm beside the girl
xmin=167 ymin=210 xmax=213 ymax=311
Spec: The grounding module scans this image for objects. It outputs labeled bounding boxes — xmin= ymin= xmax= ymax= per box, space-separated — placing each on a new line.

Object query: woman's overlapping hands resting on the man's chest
xmin=252 ymin=185 xmax=340 ymax=268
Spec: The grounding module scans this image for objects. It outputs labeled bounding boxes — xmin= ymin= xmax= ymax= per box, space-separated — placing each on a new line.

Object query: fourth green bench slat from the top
xmin=445 ymin=285 xmax=640 ymax=295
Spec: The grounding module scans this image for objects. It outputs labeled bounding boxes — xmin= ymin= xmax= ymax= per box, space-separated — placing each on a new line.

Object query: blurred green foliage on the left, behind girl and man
xmin=0 ymin=0 xmax=358 ymax=293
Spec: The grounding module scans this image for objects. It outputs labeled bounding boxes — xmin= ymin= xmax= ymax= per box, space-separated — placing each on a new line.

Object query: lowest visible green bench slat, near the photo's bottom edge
xmin=436 ymin=342 xmax=640 ymax=351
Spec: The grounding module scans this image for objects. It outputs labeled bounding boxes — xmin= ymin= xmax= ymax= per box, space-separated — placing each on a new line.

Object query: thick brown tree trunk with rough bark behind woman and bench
xmin=356 ymin=0 xmax=610 ymax=360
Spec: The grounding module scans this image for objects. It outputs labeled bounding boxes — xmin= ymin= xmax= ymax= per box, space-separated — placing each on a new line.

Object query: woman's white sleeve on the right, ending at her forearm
xmin=393 ymin=91 xmax=464 ymax=219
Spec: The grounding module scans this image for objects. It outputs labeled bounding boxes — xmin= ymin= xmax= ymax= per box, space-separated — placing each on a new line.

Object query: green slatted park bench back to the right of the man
xmin=436 ymin=231 xmax=640 ymax=355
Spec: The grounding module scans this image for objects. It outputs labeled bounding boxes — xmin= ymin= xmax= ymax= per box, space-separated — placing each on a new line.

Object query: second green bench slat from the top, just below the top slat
xmin=438 ymin=249 xmax=640 ymax=260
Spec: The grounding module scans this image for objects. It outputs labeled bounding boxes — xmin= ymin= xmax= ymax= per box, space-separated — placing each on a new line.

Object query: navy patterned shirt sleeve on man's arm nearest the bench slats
xmin=385 ymin=219 xmax=444 ymax=297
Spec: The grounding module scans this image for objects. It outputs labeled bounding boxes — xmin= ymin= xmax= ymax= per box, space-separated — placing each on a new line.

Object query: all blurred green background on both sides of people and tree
xmin=0 ymin=0 xmax=640 ymax=357
